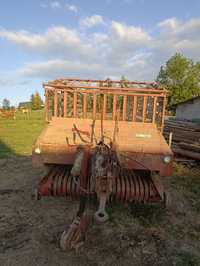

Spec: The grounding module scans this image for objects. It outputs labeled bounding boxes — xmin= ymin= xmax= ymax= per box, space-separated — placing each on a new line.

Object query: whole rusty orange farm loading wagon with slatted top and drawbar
xmin=32 ymin=79 xmax=173 ymax=249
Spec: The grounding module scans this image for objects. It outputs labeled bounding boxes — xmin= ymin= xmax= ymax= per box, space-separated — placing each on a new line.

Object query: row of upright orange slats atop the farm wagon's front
xmin=45 ymin=89 xmax=166 ymax=129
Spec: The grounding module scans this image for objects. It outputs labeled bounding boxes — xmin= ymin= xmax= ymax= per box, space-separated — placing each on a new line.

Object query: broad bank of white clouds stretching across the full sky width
xmin=0 ymin=15 xmax=200 ymax=84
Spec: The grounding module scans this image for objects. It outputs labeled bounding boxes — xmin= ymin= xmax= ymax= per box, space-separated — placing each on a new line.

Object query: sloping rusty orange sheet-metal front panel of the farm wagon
xmin=33 ymin=118 xmax=173 ymax=175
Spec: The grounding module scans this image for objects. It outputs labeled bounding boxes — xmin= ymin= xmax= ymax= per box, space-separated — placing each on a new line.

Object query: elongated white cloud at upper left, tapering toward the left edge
xmin=0 ymin=27 xmax=93 ymax=58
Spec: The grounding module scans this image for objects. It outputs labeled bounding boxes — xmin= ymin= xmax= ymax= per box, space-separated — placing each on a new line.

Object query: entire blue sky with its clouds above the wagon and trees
xmin=0 ymin=0 xmax=200 ymax=106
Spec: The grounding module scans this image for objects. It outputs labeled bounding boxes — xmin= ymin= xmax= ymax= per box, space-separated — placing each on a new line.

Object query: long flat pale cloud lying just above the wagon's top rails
xmin=18 ymin=55 xmax=152 ymax=80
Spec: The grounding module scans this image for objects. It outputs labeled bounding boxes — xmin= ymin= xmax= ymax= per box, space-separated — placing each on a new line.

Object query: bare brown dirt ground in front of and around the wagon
xmin=0 ymin=157 xmax=200 ymax=266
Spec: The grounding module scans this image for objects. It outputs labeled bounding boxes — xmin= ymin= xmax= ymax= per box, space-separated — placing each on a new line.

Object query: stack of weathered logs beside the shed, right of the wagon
xmin=163 ymin=120 xmax=200 ymax=160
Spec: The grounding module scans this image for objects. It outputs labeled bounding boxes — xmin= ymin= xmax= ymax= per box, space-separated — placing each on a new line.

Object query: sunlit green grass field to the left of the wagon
xmin=0 ymin=110 xmax=45 ymax=158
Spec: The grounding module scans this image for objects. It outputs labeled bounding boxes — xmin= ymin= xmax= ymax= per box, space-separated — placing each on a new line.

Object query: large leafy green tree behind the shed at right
xmin=156 ymin=53 xmax=200 ymax=106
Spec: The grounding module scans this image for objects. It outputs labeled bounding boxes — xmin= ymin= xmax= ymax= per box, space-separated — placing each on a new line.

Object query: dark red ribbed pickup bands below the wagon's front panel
xmin=38 ymin=165 xmax=163 ymax=203
